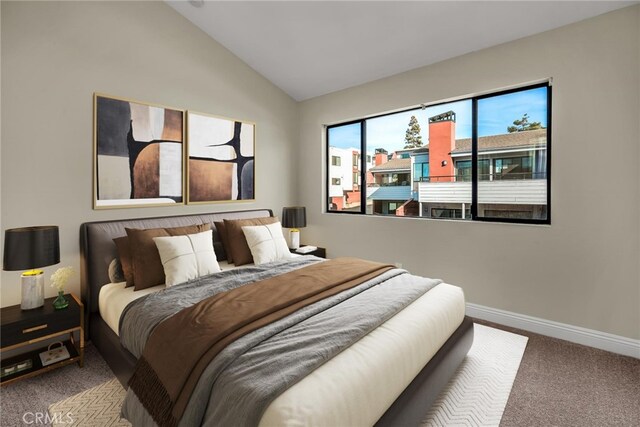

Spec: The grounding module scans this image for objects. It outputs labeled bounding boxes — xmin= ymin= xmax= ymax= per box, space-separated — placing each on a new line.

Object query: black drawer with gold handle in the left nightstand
xmin=0 ymin=307 xmax=80 ymax=348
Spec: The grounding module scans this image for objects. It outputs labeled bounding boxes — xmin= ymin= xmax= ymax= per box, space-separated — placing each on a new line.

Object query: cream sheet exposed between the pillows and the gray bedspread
xmin=98 ymin=261 xmax=242 ymax=336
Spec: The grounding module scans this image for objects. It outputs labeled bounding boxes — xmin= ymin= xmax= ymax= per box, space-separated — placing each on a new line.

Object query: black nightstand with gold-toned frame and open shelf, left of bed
xmin=0 ymin=294 xmax=84 ymax=386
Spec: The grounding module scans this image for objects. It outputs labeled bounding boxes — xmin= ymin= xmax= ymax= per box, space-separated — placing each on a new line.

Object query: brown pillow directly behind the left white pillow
xmin=125 ymin=224 xmax=211 ymax=291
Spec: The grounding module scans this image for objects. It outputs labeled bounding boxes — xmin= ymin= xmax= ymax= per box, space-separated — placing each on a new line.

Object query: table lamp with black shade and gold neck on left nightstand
xmin=2 ymin=225 xmax=60 ymax=310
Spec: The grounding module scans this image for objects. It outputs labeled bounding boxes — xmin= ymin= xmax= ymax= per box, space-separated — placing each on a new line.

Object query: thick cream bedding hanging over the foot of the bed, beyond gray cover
xmin=260 ymin=283 xmax=465 ymax=427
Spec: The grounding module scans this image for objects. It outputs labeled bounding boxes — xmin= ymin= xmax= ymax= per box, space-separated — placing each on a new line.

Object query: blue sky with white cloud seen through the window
xmin=329 ymin=87 xmax=547 ymax=153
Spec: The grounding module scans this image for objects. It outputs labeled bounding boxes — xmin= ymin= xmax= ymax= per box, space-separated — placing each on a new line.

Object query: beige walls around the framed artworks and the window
xmin=0 ymin=1 xmax=640 ymax=338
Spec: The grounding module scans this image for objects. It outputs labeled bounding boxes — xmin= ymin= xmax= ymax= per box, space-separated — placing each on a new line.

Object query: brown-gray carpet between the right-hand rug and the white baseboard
xmin=475 ymin=320 xmax=640 ymax=427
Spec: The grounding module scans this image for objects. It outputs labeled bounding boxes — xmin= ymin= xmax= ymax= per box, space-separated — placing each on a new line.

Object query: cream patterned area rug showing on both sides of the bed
xmin=49 ymin=324 xmax=528 ymax=427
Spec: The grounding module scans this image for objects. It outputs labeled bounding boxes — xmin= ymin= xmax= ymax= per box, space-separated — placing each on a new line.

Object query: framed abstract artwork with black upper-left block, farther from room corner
xmin=93 ymin=93 xmax=184 ymax=209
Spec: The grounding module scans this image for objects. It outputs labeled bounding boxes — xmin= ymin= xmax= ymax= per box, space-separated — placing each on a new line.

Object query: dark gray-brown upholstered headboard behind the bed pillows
xmin=80 ymin=209 xmax=273 ymax=324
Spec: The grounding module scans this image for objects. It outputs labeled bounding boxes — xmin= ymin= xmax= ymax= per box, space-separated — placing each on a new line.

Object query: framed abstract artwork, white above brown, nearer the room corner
xmin=187 ymin=111 xmax=256 ymax=204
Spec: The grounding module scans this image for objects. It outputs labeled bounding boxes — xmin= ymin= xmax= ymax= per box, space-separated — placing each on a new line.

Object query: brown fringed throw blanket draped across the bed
xmin=129 ymin=258 xmax=393 ymax=426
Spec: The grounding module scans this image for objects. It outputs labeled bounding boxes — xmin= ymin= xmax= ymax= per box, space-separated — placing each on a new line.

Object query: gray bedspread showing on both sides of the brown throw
xmin=120 ymin=256 xmax=439 ymax=426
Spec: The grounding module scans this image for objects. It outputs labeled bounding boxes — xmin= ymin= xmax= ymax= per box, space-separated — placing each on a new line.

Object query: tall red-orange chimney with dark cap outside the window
xmin=429 ymin=111 xmax=456 ymax=182
